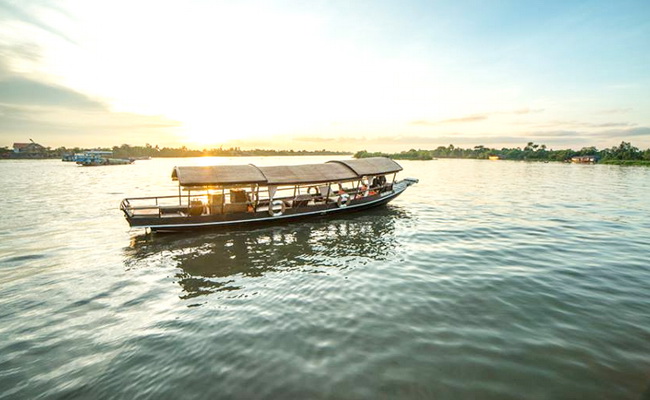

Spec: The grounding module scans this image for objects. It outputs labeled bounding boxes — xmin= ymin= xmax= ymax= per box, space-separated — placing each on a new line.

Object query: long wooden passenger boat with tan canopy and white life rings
xmin=120 ymin=157 xmax=418 ymax=231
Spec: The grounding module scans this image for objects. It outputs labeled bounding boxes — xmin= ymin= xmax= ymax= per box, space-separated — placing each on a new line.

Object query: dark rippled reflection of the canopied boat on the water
xmin=125 ymin=207 xmax=412 ymax=299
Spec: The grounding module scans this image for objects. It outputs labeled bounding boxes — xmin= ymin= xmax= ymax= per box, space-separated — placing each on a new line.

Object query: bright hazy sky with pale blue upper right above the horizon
xmin=0 ymin=0 xmax=650 ymax=151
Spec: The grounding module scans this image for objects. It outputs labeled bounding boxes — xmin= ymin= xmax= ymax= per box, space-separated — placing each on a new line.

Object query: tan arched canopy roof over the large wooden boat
xmin=172 ymin=157 xmax=402 ymax=186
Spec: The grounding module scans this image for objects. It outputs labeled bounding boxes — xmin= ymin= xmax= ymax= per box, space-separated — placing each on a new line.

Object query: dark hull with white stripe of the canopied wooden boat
xmin=126 ymin=182 xmax=410 ymax=231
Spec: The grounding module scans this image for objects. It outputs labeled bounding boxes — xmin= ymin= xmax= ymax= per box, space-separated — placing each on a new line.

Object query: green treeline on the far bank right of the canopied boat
xmin=354 ymin=142 xmax=650 ymax=165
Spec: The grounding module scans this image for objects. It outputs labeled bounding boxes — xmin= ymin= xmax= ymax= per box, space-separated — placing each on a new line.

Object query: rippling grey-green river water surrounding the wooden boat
xmin=0 ymin=157 xmax=650 ymax=399
